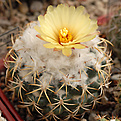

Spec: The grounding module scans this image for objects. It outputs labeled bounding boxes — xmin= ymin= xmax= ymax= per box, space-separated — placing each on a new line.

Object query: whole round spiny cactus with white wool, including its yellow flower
xmin=4 ymin=5 xmax=112 ymax=120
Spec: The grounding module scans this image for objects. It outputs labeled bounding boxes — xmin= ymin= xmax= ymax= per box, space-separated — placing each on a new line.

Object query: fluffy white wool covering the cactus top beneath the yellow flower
xmin=13 ymin=22 xmax=104 ymax=86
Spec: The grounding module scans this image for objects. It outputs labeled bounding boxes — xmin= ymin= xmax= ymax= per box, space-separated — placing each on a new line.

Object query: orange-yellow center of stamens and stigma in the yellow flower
xmin=59 ymin=28 xmax=72 ymax=44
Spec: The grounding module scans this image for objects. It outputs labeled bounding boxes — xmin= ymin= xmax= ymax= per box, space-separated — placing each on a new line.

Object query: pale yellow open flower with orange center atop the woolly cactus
xmin=35 ymin=4 xmax=98 ymax=56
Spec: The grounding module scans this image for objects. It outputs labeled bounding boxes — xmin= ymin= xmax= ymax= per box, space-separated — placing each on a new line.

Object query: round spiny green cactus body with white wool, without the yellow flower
xmin=5 ymin=4 xmax=111 ymax=120
